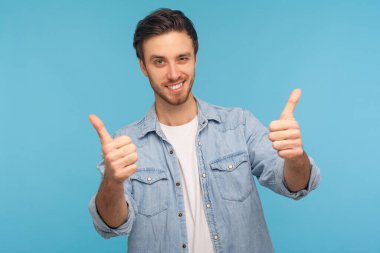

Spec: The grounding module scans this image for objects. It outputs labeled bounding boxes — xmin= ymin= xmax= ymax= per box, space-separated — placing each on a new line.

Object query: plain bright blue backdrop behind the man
xmin=0 ymin=0 xmax=380 ymax=253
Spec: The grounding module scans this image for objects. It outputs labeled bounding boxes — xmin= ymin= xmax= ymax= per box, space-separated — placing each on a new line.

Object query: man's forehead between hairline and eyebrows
xmin=143 ymin=31 xmax=194 ymax=58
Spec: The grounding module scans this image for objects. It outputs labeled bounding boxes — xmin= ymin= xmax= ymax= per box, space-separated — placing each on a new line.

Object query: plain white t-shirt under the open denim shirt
xmin=160 ymin=117 xmax=214 ymax=253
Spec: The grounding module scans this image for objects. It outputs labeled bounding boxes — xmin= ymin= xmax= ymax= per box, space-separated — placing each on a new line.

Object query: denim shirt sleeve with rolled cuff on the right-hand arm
xmin=244 ymin=111 xmax=320 ymax=200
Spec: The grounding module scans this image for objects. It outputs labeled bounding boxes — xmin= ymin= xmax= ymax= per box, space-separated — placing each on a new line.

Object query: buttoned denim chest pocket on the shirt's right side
xmin=210 ymin=152 xmax=253 ymax=201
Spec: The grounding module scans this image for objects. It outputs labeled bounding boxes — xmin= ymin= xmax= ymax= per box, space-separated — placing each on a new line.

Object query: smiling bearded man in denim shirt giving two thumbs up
xmin=90 ymin=9 xmax=319 ymax=253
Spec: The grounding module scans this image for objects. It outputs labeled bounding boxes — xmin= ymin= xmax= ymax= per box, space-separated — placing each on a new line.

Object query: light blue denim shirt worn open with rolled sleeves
xmin=89 ymin=99 xmax=320 ymax=253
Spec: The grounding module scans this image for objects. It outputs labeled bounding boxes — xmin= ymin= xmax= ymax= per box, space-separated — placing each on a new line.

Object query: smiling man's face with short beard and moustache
xmin=140 ymin=31 xmax=196 ymax=105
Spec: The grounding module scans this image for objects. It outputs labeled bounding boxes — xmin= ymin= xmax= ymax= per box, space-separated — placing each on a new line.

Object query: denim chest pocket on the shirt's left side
xmin=130 ymin=168 xmax=168 ymax=216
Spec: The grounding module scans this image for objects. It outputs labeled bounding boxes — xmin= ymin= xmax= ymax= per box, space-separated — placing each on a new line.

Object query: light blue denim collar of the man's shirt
xmin=139 ymin=97 xmax=221 ymax=138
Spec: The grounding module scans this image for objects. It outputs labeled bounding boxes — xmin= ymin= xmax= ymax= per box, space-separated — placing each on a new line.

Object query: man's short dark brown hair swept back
xmin=133 ymin=8 xmax=198 ymax=61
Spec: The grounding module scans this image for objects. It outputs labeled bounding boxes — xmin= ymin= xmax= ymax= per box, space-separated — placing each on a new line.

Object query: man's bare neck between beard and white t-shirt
xmin=155 ymin=93 xmax=197 ymax=126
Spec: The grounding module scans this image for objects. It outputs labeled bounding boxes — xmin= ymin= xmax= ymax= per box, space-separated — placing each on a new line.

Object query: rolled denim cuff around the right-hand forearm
xmin=277 ymin=156 xmax=320 ymax=200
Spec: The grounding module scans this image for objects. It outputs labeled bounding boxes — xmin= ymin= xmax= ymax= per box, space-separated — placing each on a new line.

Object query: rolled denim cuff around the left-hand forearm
xmin=89 ymin=194 xmax=135 ymax=239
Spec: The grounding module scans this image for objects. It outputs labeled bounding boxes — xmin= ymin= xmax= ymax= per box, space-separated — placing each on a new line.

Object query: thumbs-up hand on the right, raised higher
xmin=269 ymin=89 xmax=304 ymax=159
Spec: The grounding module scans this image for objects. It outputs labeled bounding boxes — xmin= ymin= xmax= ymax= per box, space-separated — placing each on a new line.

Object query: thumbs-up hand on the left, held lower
xmin=89 ymin=114 xmax=138 ymax=183
